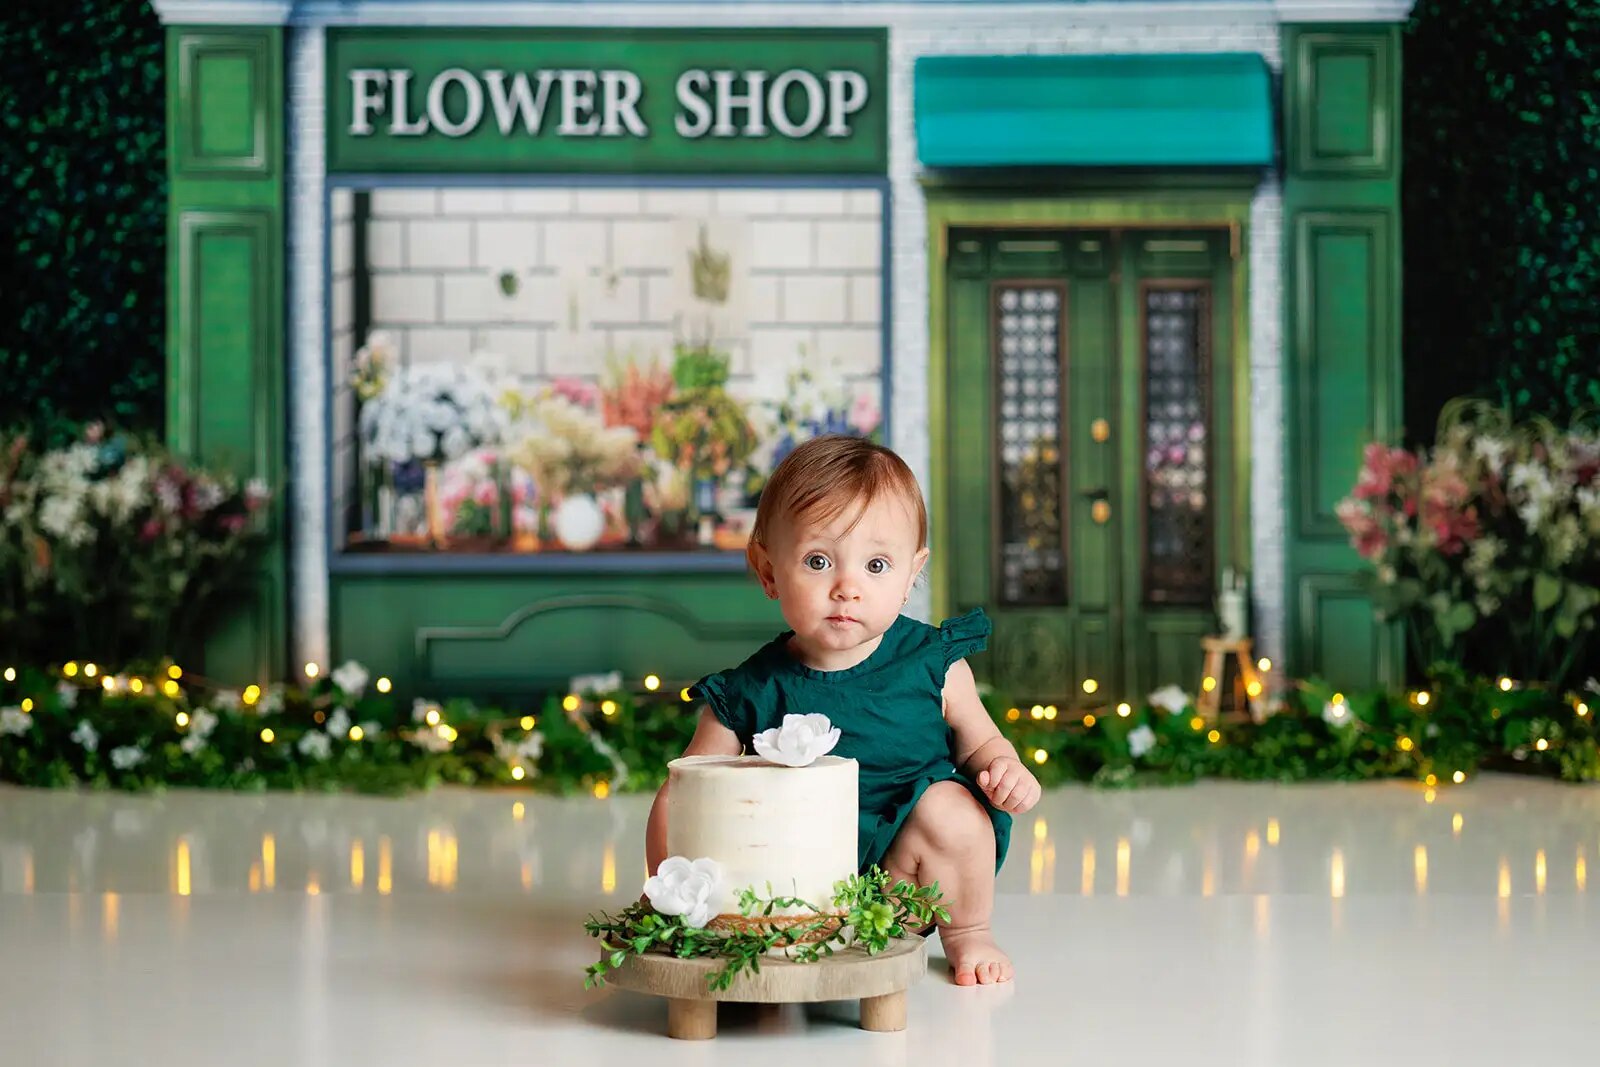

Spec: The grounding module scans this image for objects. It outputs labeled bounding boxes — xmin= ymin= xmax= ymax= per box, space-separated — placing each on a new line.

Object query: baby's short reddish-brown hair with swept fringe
xmin=750 ymin=434 xmax=928 ymax=552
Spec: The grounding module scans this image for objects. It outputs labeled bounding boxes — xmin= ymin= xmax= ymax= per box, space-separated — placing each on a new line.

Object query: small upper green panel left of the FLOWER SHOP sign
xmin=176 ymin=29 xmax=270 ymax=179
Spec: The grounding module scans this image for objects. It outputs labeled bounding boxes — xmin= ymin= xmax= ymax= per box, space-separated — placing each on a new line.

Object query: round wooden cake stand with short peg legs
xmin=605 ymin=937 xmax=928 ymax=1040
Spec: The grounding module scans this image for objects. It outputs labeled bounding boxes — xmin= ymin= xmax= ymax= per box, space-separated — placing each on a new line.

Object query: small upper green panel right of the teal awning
xmin=1285 ymin=30 xmax=1398 ymax=179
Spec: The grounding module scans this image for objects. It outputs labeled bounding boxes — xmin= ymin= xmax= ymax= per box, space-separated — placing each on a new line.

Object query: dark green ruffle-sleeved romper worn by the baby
xmin=691 ymin=608 xmax=1011 ymax=870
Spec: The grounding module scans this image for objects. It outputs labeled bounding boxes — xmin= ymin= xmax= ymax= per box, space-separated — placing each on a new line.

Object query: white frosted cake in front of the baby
xmin=667 ymin=755 xmax=858 ymax=918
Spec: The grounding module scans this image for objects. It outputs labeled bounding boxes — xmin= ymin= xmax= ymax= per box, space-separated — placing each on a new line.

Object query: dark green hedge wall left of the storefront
xmin=0 ymin=0 xmax=166 ymax=442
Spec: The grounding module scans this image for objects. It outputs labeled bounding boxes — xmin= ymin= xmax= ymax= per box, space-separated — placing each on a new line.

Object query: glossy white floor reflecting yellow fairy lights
xmin=0 ymin=777 xmax=1600 ymax=1067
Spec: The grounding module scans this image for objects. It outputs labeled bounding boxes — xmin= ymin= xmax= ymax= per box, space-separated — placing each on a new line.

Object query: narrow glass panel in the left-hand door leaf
xmin=992 ymin=282 xmax=1067 ymax=606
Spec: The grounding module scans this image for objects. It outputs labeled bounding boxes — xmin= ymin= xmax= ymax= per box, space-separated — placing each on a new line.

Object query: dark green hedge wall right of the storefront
xmin=1402 ymin=0 xmax=1600 ymax=442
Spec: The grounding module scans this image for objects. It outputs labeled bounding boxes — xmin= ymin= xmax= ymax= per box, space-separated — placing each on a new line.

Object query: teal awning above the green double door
xmin=915 ymin=53 xmax=1272 ymax=166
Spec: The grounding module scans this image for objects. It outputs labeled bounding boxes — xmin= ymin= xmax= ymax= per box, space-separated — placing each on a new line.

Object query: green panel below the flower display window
xmin=331 ymin=574 xmax=784 ymax=696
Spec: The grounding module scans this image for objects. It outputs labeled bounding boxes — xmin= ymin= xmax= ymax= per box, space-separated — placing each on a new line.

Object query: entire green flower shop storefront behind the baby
xmin=157 ymin=0 xmax=1408 ymax=704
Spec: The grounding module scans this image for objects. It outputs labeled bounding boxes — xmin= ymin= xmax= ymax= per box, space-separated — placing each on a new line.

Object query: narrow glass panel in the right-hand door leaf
xmin=1142 ymin=283 xmax=1214 ymax=605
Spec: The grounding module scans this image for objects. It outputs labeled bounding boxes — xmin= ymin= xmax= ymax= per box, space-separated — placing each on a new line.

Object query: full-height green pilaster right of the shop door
xmin=1283 ymin=26 xmax=1405 ymax=686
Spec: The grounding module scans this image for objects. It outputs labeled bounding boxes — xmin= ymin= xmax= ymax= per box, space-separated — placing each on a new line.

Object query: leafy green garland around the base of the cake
xmin=584 ymin=867 xmax=950 ymax=990
